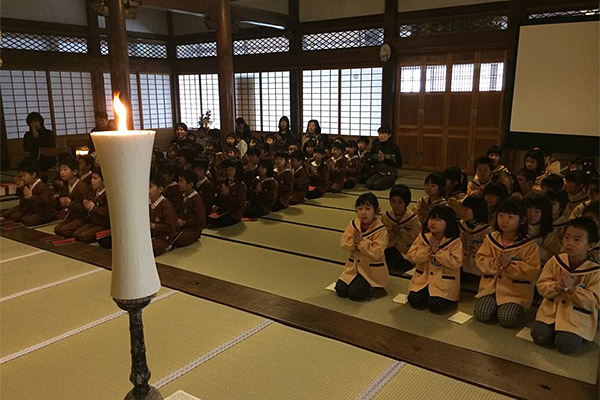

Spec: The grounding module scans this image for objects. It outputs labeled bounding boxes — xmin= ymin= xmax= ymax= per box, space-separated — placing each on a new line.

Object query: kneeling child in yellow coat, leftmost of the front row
xmin=335 ymin=193 xmax=390 ymax=300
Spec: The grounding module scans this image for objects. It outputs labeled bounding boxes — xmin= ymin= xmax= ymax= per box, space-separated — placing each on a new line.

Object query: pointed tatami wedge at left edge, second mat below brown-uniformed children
xmin=0 ymin=250 xmax=96 ymax=297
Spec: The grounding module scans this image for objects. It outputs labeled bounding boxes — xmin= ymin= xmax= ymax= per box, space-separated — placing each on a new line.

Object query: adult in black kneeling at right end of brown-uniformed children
xmin=366 ymin=126 xmax=402 ymax=190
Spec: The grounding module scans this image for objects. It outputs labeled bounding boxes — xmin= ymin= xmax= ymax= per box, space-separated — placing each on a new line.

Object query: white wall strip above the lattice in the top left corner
xmin=0 ymin=0 xmax=87 ymax=25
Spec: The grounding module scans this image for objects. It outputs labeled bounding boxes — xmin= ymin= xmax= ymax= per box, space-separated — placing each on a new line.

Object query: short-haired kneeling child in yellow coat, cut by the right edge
xmin=531 ymin=218 xmax=600 ymax=354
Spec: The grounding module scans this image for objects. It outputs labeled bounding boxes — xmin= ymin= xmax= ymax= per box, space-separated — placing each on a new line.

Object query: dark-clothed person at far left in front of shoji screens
xmin=23 ymin=112 xmax=56 ymax=175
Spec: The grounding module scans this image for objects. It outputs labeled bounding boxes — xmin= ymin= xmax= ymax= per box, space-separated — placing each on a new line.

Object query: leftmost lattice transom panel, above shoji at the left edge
xmin=0 ymin=32 xmax=87 ymax=53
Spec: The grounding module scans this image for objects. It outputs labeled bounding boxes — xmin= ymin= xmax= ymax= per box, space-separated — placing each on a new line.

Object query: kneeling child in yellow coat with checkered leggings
xmin=475 ymin=199 xmax=540 ymax=328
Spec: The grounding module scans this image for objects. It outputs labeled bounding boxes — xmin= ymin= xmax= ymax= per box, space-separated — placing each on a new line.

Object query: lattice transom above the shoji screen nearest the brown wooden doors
xmin=302 ymin=28 xmax=383 ymax=51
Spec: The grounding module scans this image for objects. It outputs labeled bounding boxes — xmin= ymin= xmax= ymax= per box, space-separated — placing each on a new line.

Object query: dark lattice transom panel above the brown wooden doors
xmin=400 ymin=15 xmax=508 ymax=38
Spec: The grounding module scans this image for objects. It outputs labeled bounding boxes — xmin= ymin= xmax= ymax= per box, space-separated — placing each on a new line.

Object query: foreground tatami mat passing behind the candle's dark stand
xmin=0 ymin=293 xmax=262 ymax=400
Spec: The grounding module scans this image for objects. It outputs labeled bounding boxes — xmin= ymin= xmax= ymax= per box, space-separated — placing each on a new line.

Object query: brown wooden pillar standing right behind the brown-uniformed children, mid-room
xmin=217 ymin=0 xmax=235 ymax=138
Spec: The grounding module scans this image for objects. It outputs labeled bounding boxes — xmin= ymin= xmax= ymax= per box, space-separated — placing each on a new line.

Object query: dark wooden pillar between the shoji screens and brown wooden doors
xmin=381 ymin=0 xmax=398 ymax=130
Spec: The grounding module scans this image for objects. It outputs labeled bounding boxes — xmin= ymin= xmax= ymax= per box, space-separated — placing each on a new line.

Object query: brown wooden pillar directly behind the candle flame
xmin=106 ymin=0 xmax=133 ymax=129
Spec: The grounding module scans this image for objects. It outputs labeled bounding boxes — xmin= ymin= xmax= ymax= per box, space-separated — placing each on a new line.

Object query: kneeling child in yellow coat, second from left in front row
xmin=407 ymin=206 xmax=462 ymax=312
